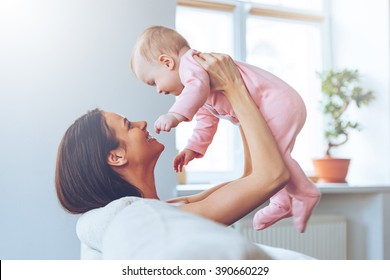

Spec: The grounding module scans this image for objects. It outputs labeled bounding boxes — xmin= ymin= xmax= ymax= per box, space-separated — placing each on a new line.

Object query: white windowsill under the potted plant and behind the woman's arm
xmin=176 ymin=183 xmax=390 ymax=196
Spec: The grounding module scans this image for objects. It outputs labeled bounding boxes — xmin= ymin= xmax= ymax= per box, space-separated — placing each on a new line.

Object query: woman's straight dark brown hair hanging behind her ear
xmin=55 ymin=109 xmax=142 ymax=214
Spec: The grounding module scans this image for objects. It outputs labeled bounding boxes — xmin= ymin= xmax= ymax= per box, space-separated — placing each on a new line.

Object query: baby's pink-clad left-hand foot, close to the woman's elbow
xmin=253 ymin=202 xmax=292 ymax=230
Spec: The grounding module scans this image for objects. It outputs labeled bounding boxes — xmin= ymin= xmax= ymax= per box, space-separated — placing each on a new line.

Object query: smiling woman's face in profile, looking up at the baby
xmin=103 ymin=112 xmax=164 ymax=164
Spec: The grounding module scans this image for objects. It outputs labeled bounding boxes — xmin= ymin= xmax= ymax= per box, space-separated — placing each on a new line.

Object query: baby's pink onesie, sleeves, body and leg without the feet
xmin=169 ymin=50 xmax=313 ymax=202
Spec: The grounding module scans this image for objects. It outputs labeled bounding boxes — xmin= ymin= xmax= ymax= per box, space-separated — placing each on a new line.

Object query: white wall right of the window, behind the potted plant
xmin=331 ymin=0 xmax=390 ymax=186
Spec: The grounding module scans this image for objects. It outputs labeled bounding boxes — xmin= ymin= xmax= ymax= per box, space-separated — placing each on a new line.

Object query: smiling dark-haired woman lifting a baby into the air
xmin=56 ymin=53 xmax=289 ymax=258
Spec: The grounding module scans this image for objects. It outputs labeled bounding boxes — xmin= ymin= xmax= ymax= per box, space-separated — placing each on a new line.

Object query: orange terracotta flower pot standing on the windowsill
xmin=313 ymin=157 xmax=351 ymax=183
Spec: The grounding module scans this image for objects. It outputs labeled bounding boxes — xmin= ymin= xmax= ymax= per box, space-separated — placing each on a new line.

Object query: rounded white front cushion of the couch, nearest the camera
xmin=101 ymin=199 xmax=270 ymax=260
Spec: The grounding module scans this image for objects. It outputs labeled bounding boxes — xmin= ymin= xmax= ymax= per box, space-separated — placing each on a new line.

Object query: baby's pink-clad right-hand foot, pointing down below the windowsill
xmin=292 ymin=192 xmax=321 ymax=233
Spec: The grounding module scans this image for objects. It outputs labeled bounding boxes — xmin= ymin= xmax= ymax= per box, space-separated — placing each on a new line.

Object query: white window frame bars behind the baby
xmin=177 ymin=0 xmax=331 ymax=184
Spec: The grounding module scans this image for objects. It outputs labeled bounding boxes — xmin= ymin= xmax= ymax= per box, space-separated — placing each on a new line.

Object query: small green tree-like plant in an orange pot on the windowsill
xmin=313 ymin=69 xmax=374 ymax=183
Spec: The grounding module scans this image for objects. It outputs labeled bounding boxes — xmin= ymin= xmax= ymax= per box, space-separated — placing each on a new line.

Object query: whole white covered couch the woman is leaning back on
xmin=76 ymin=197 xmax=311 ymax=260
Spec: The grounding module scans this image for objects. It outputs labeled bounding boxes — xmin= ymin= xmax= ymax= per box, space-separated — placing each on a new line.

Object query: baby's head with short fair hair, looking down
xmin=130 ymin=26 xmax=190 ymax=96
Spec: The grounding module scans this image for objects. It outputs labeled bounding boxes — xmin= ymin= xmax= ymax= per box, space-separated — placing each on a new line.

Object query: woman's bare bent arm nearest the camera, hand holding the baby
xmin=180 ymin=54 xmax=289 ymax=225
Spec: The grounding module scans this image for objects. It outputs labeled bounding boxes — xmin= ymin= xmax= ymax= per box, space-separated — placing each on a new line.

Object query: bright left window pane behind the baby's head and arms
xmin=176 ymin=6 xmax=235 ymax=177
